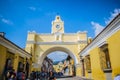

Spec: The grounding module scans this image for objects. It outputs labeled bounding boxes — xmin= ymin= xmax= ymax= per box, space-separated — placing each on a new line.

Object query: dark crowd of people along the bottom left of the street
xmin=4 ymin=67 xmax=63 ymax=80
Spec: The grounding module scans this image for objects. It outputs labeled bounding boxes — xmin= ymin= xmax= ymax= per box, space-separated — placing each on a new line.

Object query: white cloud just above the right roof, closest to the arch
xmin=91 ymin=21 xmax=104 ymax=36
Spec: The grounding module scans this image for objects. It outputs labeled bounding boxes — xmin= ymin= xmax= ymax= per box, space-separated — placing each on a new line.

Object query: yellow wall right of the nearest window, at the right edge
xmin=107 ymin=31 xmax=120 ymax=78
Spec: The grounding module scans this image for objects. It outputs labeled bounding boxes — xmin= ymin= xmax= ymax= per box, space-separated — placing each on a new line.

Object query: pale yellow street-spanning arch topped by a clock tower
xmin=25 ymin=16 xmax=88 ymax=76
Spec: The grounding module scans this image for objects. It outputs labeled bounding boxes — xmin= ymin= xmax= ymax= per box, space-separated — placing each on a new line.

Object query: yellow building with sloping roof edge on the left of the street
xmin=0 ymin=35 xmax=32 ymax=80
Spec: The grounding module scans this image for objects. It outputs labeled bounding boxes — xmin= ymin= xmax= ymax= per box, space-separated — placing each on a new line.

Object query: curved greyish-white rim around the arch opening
xmin=38 ymin=47 xmax=78 ymax=76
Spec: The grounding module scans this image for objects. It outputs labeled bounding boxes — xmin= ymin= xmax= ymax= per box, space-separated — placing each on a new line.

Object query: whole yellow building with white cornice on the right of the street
xmin=79 ymin=14 xmax=120 ymax=80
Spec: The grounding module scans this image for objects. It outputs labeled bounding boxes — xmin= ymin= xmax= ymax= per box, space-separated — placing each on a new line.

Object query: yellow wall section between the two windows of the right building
xmin=90 ymin=47 xmax=106 ymax=80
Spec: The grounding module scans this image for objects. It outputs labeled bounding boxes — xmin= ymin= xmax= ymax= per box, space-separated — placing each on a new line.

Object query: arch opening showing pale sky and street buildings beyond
xmin=41 ymin=51 xmax=75 ymax=77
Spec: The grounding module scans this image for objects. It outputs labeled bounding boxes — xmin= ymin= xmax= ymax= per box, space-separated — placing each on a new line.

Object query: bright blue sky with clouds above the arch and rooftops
xmin=0 ymin=0 xmax=120 ymax=60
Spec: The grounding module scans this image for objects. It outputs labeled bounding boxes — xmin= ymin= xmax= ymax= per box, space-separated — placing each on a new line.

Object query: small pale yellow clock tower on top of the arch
xmin=51 ymin=15 xmax=64 ymax=33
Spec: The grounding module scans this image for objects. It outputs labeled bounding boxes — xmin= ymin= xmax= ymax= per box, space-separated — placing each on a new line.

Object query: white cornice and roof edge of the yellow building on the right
xmin=79 ymin=14 xmax=120 ymax=56
